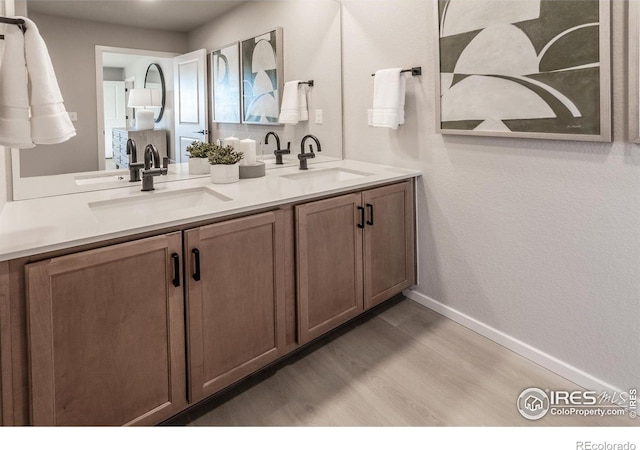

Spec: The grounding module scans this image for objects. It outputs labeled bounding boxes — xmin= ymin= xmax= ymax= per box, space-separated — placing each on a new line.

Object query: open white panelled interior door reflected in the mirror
xmin=173 ymin=49 xmax=209 ymax=163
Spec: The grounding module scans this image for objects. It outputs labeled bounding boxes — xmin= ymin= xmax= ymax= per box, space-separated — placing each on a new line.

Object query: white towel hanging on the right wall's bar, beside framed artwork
xmin=368 ymin=68 xmax=406 ymax=130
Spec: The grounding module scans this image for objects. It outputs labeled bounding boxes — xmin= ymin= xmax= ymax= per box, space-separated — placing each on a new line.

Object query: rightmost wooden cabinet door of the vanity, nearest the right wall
xmin=362 ymin=181 xmax=415 ymax=309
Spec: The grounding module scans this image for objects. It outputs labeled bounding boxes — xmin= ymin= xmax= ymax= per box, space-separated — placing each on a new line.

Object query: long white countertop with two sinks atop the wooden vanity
xmin=0 ymin=160 xmax=420 ymax=261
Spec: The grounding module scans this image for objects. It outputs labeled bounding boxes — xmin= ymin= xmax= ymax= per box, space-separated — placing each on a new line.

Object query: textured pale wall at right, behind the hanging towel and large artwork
xmin=342 ymin=0 xmax=640 ymax=389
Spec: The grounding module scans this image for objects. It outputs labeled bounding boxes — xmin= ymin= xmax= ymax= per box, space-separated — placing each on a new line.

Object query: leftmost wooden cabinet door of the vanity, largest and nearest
xmin=26 ymin=233 xmax=187 ymax=426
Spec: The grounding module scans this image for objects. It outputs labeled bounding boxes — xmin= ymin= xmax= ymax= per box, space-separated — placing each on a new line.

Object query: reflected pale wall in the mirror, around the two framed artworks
xmin=189 ymin=0 xmax=342 ymax=158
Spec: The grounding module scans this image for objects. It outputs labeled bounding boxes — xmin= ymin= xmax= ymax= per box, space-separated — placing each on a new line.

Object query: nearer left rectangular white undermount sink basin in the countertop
xmin=88 ymin=187 xmax=232 ymax=223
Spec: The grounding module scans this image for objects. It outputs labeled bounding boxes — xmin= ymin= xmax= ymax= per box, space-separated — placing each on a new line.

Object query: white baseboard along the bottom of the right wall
xmin=403 ymin=289 xmax=622 ymax=393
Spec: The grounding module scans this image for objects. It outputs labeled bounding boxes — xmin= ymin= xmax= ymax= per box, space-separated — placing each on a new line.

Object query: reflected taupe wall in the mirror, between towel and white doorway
xmin=20 ymin=13 xmax=187 ymax=177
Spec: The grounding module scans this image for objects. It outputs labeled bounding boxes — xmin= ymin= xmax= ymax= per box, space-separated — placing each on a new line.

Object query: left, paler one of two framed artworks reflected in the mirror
xmin=211 ymin=42 xmax=240 ymax=123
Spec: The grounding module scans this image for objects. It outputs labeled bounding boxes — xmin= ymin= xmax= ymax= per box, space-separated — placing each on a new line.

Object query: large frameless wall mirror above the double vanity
xmin=11 ymin=0 xmax=343 ymax=200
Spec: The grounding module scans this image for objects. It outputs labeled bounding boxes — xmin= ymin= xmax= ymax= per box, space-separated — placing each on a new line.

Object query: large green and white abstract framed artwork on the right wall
xmin=436 ymin=0 xmax=611 ymax=141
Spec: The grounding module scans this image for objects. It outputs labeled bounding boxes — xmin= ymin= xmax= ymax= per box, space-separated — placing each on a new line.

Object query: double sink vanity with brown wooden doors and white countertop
xmin=0 ymin=160 xmax=420 ymax=426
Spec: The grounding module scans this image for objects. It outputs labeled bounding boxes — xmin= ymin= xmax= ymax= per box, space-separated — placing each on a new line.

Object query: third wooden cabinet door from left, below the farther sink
xmin=296 ymin=194 xmax=363 ymax=343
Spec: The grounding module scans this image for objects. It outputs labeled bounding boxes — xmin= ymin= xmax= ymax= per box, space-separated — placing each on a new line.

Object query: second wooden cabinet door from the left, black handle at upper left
xmin=185 ymin=211 xmax=286 ymax=402
